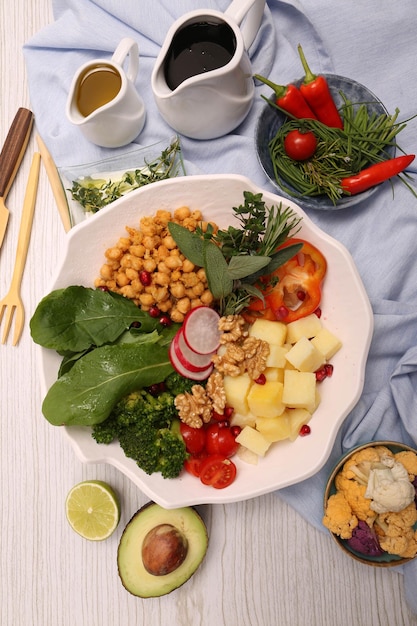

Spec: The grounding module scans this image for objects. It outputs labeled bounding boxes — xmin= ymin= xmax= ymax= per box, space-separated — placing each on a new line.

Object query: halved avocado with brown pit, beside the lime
xmin=117 ymin=502 xmax=208 ymax=598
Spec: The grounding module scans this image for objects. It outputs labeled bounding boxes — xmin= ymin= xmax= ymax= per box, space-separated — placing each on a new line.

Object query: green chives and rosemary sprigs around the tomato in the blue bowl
xmin=269 ymin=93 xmax=412 ymax=204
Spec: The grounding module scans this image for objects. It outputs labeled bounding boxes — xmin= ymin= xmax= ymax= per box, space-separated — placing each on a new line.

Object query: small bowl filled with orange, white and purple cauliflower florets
xmin=322 ymin=441 xmax=417 ymax=567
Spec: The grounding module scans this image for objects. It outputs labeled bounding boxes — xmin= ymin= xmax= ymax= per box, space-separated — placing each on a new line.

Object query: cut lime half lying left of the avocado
xmin=65 ymin=480 xmax=120 ymax=541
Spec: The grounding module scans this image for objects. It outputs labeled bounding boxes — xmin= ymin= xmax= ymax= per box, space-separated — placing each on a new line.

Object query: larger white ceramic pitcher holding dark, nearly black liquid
xmin=152 ymin=0 xmax=265 ymax=139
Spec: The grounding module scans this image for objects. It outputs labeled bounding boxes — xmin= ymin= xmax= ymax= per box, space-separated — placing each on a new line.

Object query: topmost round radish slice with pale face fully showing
xmin=182 ymin=306 xmax=221 ymax=354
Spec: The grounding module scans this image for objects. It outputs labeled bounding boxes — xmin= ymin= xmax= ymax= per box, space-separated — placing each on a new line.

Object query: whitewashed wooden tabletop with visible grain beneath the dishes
xmin=0 ymin=0 xmax=417 ymax=626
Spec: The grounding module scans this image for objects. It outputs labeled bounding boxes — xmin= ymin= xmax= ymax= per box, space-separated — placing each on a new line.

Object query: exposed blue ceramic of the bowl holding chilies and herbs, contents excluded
xmin=255 ymin=74 xmax=395 ymax=211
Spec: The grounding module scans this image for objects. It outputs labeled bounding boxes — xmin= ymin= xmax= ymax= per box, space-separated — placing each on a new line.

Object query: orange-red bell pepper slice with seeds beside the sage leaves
xmin=243 ymin=238 xmax=327 ymax=323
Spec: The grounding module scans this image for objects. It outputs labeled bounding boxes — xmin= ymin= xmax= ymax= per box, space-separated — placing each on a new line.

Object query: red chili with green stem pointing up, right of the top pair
xmin=298 ymin=45 xmax=343 ymax=128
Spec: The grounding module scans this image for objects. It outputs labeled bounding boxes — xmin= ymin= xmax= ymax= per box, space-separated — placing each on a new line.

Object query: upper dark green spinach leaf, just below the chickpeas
xmin=30 ymin=285 xmax=159 ymax=355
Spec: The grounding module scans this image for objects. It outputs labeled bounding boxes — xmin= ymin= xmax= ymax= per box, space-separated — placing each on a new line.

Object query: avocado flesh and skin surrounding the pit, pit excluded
xmin=117 ymin=502 xmax=208 ymax=598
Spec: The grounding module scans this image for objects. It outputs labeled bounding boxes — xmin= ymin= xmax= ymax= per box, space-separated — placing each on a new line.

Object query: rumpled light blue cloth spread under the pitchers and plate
xmin=24 ymin=0 xmax=417 ymax=613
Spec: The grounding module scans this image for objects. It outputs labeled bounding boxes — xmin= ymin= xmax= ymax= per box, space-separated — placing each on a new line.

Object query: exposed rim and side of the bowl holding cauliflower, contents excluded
xmin=323 ymin=441 xmax=417 ymax=567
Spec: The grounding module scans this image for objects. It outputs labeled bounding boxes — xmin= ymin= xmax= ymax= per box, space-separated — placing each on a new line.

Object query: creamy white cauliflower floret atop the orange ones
xmin=365 ymin=457 xmax=415 ymax=513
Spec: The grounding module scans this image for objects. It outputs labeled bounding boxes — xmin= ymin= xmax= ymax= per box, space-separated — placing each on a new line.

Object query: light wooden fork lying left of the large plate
xmin=0 ymin=152 xmax=40 ymax=346
